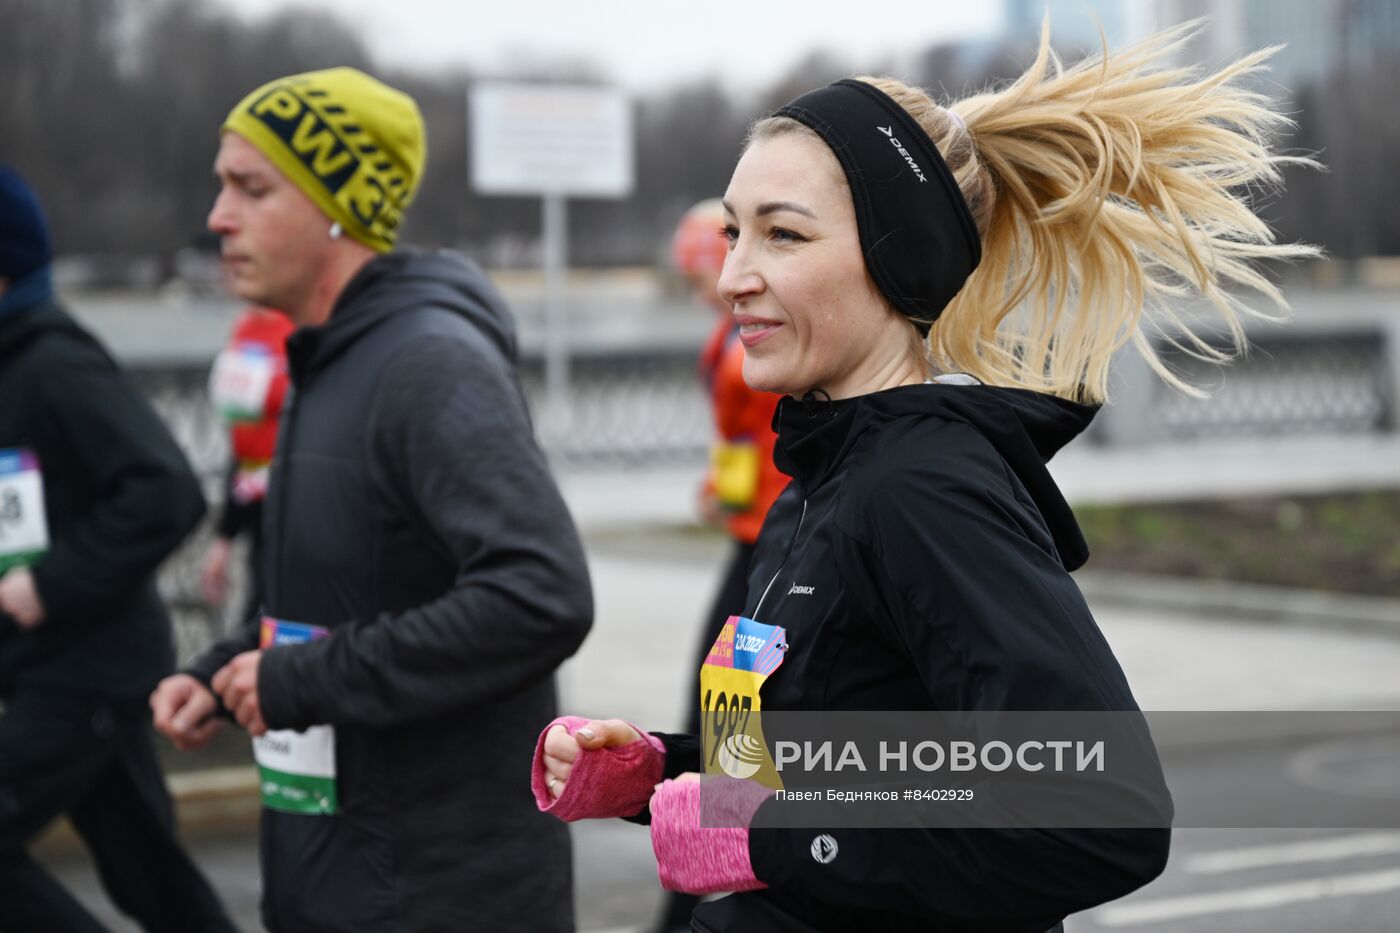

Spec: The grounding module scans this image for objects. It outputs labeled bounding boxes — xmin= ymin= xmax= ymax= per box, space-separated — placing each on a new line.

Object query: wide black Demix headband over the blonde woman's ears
xmin=774 ymin=78 xmax=981 ymax=336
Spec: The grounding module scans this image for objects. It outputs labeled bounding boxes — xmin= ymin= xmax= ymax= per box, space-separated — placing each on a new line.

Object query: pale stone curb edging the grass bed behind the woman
xmin=1074 ymin=572 xmax=1400 ymax=637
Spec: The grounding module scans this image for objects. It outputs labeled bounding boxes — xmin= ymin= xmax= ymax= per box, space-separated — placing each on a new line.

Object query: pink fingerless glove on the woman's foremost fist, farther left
xmin=529 ymin=716 xmax=666 ymax=822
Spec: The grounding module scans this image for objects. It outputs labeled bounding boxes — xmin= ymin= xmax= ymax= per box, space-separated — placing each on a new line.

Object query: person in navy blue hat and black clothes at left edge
xmin=0 ymin=165 xmax=235 ymax=933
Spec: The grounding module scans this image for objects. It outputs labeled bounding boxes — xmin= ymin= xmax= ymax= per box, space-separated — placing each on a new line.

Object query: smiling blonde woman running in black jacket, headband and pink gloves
xmin=532 ymin=27 xmax=1315 ymax=933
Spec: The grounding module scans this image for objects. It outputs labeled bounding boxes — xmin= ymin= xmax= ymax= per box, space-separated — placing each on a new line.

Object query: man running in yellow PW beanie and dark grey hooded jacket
xmin=151 ymin=69 xmax=592 ymax=933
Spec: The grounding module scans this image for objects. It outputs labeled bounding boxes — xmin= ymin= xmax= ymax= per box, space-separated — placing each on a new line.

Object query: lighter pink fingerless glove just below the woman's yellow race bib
xmin=651 ymin=778 xmax=773 ymax=894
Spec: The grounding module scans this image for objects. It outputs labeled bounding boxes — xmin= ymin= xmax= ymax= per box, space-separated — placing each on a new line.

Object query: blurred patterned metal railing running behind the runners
xmin=133 ymin=331 xmax=1396 ymax=658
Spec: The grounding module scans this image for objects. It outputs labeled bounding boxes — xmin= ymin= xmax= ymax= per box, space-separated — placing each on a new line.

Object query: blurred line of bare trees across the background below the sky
xmin=0 ymin=0 xmax=1400 ymax=265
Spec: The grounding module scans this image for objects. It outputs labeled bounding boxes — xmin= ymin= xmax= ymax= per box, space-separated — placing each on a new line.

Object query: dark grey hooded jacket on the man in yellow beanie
xmin=190 ymin=254 xmax=592 ymax=933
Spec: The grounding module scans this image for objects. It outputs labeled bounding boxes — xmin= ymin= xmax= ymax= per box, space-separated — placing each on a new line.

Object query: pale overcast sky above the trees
xmin=223 ymin=0 xmax=1001 ymax=90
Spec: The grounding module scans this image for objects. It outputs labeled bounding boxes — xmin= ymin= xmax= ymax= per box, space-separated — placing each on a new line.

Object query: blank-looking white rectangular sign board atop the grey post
xmin=469 ymin=83 xmax=633 ymax=198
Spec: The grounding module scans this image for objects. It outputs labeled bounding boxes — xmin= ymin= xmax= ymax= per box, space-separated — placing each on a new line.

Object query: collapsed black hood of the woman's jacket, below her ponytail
xmin=773 ymin=384 xmax=1098 ymax=570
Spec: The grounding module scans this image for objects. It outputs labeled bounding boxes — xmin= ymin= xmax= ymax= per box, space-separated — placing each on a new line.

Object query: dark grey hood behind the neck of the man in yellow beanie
xmin=287 ymin=251 xmax=517 ymax=381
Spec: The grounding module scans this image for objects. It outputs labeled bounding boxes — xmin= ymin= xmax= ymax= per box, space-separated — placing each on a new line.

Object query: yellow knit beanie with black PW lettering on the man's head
xmin=223 ymin=69 xmax=427 ymax=252
